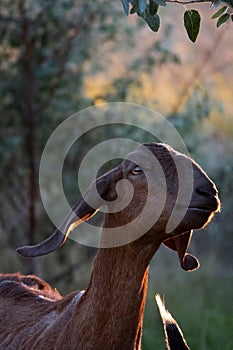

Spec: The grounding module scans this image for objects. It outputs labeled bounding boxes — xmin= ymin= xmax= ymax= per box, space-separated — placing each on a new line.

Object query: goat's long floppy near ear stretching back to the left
xmin=16 ymin=166 xmax=121 ymax=257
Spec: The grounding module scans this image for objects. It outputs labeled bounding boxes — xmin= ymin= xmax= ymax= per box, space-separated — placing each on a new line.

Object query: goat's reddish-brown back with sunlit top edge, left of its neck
xmin=0 ymin=273 xmax=82 ymax=350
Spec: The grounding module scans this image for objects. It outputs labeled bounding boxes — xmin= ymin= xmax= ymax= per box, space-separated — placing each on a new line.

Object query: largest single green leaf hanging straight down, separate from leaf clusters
xmin=184 ymin=10 xmax=201 ymax=43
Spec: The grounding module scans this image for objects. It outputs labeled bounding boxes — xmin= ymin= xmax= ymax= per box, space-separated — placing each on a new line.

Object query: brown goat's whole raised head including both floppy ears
xmin=17 ymin=143 xmax=220 ymax=271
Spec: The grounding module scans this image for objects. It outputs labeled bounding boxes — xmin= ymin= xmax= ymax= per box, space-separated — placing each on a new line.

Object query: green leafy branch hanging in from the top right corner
xmin=121 ymin=0 xmax=233 ymax=42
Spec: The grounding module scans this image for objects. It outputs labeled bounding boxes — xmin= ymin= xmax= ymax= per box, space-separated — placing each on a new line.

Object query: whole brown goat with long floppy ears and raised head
xmin=0 ymin=143 xmax=220 ymax=350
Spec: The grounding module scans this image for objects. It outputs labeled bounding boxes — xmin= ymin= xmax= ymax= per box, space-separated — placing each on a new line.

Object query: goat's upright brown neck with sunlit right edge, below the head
xmin=70 ymin=227 xmax=159 ymax=350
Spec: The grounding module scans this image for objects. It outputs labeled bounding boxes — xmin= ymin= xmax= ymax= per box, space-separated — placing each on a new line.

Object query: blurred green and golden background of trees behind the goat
xmin=0 ymin=0 xmax=233 ymax=350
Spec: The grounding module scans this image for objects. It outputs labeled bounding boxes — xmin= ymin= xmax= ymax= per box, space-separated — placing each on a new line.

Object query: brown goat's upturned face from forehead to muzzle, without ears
xmin=101 ymin=143 xmax=220 ymax=235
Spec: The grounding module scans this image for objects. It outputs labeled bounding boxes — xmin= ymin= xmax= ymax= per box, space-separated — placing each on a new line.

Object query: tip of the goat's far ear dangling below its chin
xmin=163 ymin=231 xmax=200 ymax=271
